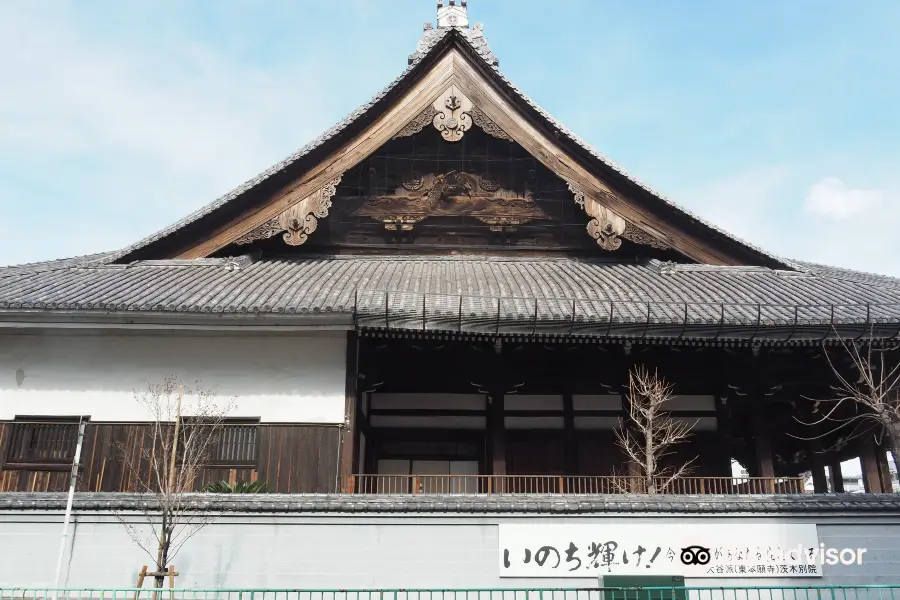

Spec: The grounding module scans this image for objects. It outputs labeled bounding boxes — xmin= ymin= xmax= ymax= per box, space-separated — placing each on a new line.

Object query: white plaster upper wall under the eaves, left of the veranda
xmin=0 ymin=333 xmax=346 ymax=423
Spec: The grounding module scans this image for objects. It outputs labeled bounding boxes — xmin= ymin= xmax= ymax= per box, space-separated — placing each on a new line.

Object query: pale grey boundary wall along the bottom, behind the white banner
xmin=0 ymin=511 xmax=900 ymax=588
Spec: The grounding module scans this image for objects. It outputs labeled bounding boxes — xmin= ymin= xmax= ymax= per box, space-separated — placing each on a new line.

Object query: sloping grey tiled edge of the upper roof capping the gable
xmin=108 ymin=21 xmax=793 ymax=267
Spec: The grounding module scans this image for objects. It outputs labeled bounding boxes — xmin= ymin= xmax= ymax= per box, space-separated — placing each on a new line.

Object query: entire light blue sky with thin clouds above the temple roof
xmin=0 ymin=0 xmax=900 ymax=276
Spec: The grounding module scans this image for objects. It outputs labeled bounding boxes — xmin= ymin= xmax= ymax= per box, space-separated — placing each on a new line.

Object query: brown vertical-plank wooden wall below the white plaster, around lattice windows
xmin=0 ymin=422 xmax=340 ymax=493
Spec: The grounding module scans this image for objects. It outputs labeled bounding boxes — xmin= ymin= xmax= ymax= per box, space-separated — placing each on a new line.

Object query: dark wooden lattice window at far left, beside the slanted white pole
xmin=3 ymin=417 xmax=79 ymax=470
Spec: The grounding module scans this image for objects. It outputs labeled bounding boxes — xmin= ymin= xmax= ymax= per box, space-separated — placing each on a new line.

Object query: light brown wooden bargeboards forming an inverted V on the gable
xmin=177 ymin=49 xmax=738 ymax=264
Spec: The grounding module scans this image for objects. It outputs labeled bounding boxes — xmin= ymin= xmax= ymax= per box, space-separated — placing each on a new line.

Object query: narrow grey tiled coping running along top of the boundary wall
xmin=0 ymin=492 xmax=900 ymax=514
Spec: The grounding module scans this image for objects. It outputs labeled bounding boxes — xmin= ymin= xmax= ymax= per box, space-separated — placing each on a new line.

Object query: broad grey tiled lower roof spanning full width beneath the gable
xmin=0 ymin=256 xmax=900 ymax=341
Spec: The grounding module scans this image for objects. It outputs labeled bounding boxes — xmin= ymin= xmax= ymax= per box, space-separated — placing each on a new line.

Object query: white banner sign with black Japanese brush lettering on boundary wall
xmin=499 ymin=523 xmax=835 ymax=577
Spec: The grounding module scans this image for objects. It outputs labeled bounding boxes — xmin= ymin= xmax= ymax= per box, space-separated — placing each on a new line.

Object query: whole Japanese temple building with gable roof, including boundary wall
xmin=0 ymin=0 xmax=900 ymax=588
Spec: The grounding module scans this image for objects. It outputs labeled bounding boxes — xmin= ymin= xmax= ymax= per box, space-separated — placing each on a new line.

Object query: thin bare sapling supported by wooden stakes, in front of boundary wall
xmin=116 ymin=377 xmax=231 ymax=588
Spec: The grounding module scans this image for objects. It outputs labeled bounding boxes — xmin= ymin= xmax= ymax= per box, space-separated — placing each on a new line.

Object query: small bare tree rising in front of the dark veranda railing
xmin=616 ymin=367 xmax=696 ymax=494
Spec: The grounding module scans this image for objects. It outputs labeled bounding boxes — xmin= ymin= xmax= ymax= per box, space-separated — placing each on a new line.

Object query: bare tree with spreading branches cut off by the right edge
xmin=793 ymin=336 xmax=900 ymax=476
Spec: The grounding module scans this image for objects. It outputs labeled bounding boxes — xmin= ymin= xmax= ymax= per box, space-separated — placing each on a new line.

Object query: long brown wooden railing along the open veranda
xmin=344 ymin=475 xmax=805 ymax=495
